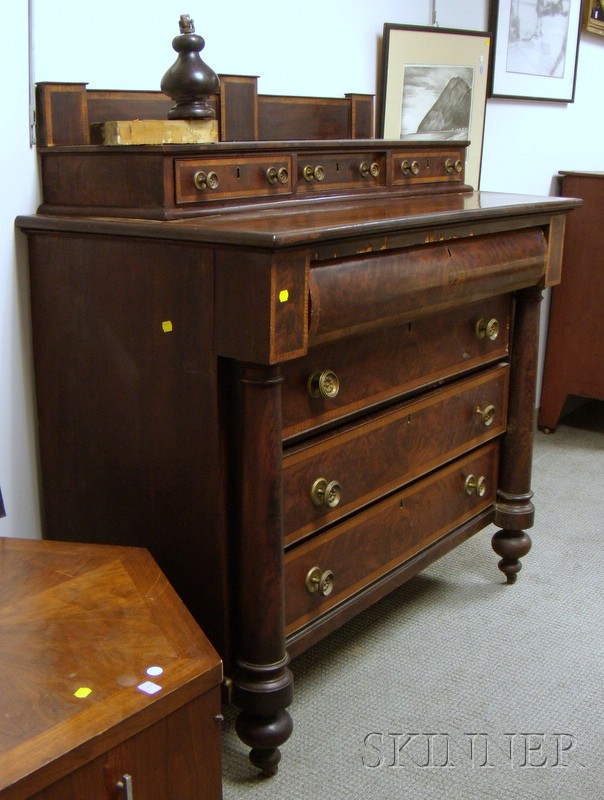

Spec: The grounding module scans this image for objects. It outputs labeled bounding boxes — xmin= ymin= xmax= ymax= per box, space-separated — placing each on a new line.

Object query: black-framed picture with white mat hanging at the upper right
xmin=490 ymin=0 xmax=581 ymax=103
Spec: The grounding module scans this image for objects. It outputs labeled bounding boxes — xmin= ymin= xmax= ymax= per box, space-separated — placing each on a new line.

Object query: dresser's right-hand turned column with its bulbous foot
xmin=492 ymin=286 xmax=543 ymax=583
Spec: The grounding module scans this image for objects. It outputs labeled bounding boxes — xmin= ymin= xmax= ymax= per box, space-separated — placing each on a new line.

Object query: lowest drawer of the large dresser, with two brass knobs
xmin=285 ymin=441 xmax=498 ymax=635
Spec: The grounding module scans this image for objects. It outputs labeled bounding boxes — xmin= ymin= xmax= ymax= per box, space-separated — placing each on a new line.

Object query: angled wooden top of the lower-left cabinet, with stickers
xmin=0 ymin=538 xmax=222 ymax=800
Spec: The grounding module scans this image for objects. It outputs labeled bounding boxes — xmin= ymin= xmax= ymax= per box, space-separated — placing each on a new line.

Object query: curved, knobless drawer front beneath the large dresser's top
xmin=309 ymin=228 xmax=547 ymax=346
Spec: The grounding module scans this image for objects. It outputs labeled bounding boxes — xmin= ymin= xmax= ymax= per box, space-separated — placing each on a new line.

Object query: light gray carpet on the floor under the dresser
xmin=223 ymin=403 xmax=604 ymax=800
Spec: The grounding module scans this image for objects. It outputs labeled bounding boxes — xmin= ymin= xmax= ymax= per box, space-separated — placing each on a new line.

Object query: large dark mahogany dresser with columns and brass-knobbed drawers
xmin=18 ymin=78 xmax=576 ymax=774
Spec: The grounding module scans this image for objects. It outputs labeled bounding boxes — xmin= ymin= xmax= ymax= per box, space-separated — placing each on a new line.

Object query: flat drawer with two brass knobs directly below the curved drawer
xmin=282 ymin=295 xmax=512 ymax=439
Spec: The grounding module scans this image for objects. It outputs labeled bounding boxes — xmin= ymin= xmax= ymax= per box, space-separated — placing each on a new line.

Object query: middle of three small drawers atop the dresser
xmin=297 ymin=152 xmax=387 ymax=193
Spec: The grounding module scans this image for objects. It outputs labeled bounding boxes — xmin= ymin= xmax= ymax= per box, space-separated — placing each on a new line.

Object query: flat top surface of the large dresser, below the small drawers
xmin=16 ymin=192 xmax=580 ymax=249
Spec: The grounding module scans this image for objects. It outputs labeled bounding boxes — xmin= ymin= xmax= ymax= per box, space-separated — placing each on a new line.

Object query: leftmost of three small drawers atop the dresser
xmin=174 ymin=154 xmax=292 ymax=204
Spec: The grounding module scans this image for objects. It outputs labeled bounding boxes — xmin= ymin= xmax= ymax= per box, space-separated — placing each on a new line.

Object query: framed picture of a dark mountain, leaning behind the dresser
xmin=380 ymin=22 xmax=490 ymax=189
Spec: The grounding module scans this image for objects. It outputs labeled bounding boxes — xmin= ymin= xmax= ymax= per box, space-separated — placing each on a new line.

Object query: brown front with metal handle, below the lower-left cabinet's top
xmin=30 ymin=688 xmax=222 ymax=800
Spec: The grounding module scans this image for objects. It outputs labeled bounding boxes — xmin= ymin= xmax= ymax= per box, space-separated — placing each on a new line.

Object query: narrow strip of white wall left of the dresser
xmin=0 ymin=2 xmax=40 ymax=536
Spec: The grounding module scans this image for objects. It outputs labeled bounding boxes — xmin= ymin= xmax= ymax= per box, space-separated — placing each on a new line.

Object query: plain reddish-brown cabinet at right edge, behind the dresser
xmin=539 ymin=172 xmax=604 ymax=431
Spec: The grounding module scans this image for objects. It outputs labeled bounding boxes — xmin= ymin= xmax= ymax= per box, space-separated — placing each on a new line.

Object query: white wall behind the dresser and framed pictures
xmin=0 ymin=0 xmax=604 ymax=536
